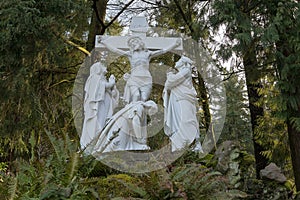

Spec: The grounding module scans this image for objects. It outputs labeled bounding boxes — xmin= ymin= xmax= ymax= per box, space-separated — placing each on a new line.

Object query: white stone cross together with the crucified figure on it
xmin=95 ymin=17 xmax=183 ymax=103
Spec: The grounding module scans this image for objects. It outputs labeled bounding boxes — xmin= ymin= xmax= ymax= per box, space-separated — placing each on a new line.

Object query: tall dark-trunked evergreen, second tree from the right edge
xmin=211 ymin=0 xmax=268 ymax=178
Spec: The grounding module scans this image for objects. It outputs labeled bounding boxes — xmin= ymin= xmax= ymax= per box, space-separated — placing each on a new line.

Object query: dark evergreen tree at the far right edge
xmin=274 ymin=0 xmax=300 ymax=191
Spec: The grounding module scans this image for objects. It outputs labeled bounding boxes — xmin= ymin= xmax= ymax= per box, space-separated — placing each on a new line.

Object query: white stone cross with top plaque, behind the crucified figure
xmin=95 ymin=16 xmax=183 ymax=51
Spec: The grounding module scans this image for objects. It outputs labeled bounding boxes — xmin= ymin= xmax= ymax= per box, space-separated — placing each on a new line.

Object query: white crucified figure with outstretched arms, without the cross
xmin=102 ymin=36 xmax=181 ymax=103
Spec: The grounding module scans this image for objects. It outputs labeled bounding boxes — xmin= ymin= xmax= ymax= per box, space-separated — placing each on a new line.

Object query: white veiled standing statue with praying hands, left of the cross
xmin=80 ymin=62 xmax=119 ymax=153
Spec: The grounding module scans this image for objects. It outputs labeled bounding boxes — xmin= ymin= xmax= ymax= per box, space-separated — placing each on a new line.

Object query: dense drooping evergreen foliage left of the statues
xmin=0 ymin=0 xmax=87 ymax=161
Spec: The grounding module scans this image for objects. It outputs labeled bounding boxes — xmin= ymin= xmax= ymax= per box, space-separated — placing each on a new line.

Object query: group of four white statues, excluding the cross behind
xmin=80 ymin=21 xmax=202 ymax=155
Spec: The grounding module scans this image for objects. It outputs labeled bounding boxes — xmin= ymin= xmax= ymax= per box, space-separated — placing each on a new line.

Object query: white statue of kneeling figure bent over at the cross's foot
xmin=92 ymin=100 xmax=158 ymax=157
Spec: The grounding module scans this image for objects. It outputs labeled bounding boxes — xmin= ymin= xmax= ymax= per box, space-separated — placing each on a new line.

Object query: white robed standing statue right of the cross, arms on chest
xmin=163 ymin=56 xmax=202 ymax=152
